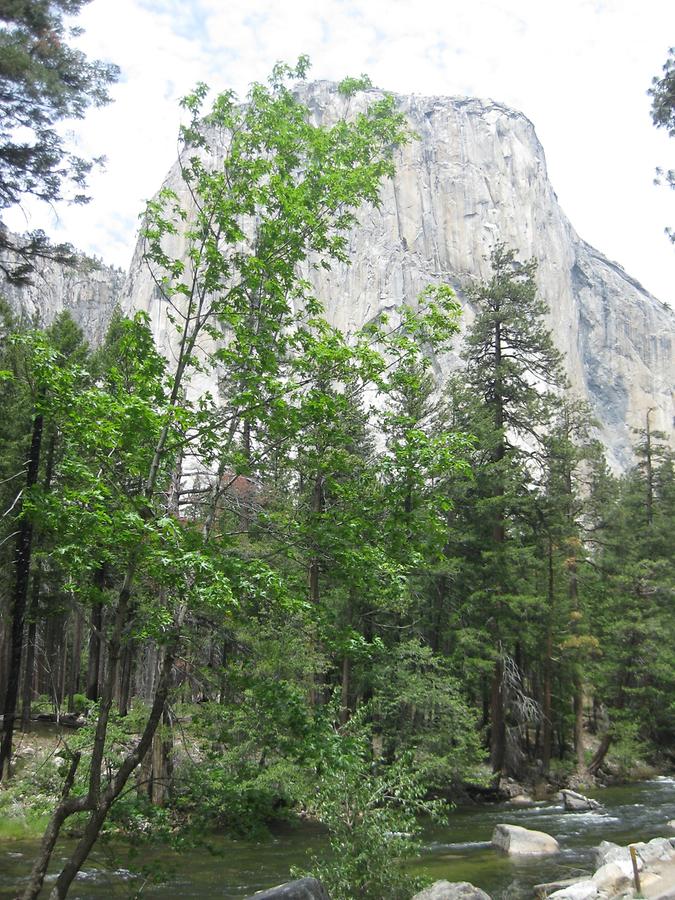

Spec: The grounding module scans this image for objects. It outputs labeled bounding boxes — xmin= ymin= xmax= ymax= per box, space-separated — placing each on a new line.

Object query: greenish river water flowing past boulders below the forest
xmin=0 ymin=777 xmax=675 ymax=900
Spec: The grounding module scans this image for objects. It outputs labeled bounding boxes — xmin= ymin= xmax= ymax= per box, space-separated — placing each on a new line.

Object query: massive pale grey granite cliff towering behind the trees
xmin=2 ymin=82 xmax=675 ymax=468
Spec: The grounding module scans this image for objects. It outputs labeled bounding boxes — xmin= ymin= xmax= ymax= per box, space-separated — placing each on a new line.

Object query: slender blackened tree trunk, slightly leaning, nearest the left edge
xmin=0 ymin=414 xmax=44 ymax=780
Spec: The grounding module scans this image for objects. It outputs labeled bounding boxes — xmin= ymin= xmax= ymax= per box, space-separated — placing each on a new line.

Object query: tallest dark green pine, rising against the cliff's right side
xmin=462 ymin=244 xmax=564 ymax=771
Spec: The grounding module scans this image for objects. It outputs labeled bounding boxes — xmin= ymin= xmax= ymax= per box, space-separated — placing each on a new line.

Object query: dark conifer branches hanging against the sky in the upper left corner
xmin=0 ymin=0 xmax=119 ymax=284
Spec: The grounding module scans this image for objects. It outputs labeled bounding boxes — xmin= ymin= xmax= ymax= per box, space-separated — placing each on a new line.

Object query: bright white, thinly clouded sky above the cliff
xmin=4 ymin=0 xmax=675 ymax=306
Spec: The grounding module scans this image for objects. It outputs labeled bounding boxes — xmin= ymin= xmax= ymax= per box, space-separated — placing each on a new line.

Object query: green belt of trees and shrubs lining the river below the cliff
xmin=0 ymin=8 xmax=675 ymax=900
